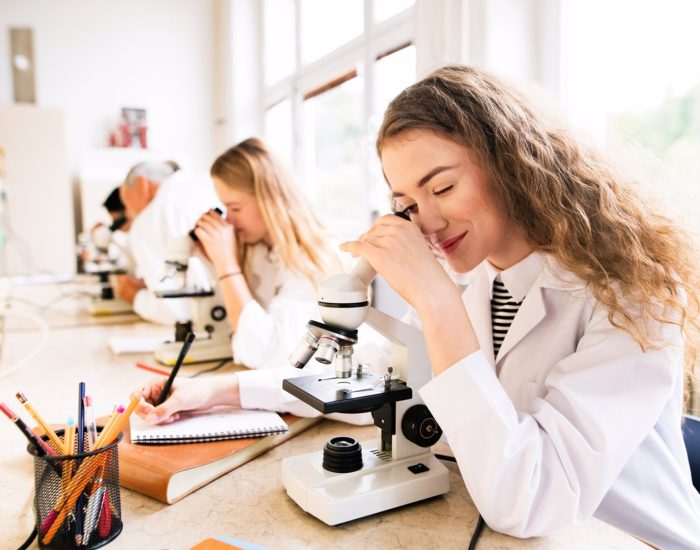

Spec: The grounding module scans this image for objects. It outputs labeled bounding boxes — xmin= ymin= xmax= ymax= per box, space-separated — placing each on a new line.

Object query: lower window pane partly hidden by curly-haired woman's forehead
xmin=368 ymin=46 xmax=416 ymax=214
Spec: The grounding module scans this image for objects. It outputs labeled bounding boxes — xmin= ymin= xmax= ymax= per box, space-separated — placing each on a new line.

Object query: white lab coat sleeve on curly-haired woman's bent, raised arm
xmin=420 ymin=302 xmax=683 ymax=537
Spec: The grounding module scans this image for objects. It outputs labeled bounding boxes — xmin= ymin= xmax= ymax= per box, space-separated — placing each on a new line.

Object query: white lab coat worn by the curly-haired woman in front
xmin=420 ymin=253 xmax=700 ymax=549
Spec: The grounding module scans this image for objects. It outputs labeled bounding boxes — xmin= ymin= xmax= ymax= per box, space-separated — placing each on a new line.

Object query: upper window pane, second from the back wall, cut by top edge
xmin=301 ymin=0 xmax=364 ymax=63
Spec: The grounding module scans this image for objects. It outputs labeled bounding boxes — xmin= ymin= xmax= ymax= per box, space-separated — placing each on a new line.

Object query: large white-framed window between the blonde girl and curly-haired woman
xmin=263 ymin=0 xmax=416 ymax=242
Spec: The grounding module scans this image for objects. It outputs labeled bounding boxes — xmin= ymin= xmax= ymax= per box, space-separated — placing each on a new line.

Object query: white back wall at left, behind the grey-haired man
xmin=0 ymin=0 xmax=215 ymax=173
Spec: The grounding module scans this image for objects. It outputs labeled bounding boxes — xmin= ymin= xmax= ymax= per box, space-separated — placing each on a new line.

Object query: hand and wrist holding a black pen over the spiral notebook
xmin=135 ymin=374 xmax=241 ymax=424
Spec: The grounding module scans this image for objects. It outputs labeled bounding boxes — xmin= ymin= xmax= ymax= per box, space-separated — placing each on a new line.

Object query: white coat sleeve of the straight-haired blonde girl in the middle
xmin=232 ymin=279 xmax=318 ymax=369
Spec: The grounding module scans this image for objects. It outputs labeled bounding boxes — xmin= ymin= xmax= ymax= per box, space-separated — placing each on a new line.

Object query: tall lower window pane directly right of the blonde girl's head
xmin=304 ymin=77 xmax=369 ymax=238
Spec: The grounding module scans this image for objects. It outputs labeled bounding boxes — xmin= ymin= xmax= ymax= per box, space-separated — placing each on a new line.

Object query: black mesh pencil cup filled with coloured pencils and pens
xmin=27 ymin=430 xmax=122 ymax=550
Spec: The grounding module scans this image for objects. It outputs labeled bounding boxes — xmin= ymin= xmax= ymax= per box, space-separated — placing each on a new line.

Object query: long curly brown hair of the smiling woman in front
xmin=377 ymin=65 xmax=700 ymax=390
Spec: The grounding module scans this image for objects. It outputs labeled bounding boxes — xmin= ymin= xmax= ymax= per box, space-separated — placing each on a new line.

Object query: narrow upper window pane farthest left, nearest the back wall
xmin=263 ymin=0 xmax=296 ymax=84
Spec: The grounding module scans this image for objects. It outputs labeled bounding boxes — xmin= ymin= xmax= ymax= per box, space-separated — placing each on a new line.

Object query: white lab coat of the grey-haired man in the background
xmin=129 ymin=170 xmax=220 ymax=325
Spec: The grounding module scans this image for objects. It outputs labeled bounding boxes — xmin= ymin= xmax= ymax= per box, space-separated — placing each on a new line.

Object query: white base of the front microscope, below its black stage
xmin=282 ymin=441 xmax=450 ymax=525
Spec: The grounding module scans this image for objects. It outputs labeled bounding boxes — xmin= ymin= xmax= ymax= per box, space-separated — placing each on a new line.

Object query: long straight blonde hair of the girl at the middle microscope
xmin=210 ymin=138 xmax=340 ymax=284
